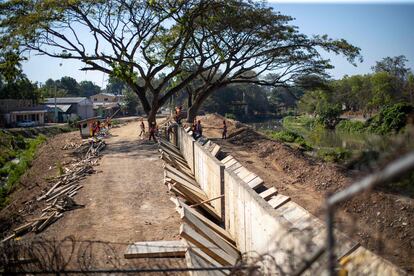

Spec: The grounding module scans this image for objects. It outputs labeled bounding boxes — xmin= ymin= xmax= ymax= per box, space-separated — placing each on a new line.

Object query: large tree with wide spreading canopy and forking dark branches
xmin=0 ymin=0 xmax=359 ymax=121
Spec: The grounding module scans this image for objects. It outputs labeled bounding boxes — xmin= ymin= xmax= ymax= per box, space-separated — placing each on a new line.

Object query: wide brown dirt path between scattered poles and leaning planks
xmin=34 ymin=122 xmax=184 ymax=268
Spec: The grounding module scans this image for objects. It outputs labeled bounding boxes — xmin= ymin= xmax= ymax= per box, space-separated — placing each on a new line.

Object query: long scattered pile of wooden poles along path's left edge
xmin=1 ymin=140 xmax=105 ymax=242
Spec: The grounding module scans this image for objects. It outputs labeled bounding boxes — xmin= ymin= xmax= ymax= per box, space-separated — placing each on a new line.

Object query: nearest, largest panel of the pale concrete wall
xmin=224 ymin=170 xmax=328 ymax=274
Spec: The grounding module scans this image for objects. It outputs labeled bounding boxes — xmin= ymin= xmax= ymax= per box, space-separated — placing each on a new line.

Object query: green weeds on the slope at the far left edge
xmin=0 ymin=135 xmax=46 ymax=209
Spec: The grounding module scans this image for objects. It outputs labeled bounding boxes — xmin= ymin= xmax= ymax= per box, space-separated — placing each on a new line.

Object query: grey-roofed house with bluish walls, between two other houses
xmin=44 ymin=97 xmax=93 ymax=122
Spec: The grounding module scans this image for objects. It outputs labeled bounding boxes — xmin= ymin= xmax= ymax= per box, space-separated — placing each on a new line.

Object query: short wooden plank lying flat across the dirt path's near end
xmin=124 ymin=241 xmax=187 ymax=259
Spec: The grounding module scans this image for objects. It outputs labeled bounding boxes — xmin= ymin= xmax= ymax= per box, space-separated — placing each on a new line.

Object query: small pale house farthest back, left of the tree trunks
xmin=90 ymin=93 xmax=121 ymax=117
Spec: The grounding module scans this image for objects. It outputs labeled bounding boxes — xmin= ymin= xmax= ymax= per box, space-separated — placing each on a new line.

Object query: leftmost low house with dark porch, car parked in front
xmin=0 ymin=99 xmax=47 ymax=127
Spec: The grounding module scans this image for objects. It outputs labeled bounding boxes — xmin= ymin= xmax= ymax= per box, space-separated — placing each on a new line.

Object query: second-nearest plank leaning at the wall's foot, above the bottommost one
xmin=180 ymin=223 xmax=237 ymax=265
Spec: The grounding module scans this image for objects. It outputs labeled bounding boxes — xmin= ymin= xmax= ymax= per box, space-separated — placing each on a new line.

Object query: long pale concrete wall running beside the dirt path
xmin=173 ymin=128 xmax=402 ymax=275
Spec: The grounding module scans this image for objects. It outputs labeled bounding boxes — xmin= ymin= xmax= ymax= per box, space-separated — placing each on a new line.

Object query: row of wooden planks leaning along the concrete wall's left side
xmin=156 ymin=140 xmax=240 ymax=275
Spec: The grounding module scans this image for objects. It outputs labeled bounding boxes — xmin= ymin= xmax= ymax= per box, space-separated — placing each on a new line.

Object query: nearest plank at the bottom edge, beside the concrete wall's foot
xmin=185 ymin=246 xmax=230 ymax=276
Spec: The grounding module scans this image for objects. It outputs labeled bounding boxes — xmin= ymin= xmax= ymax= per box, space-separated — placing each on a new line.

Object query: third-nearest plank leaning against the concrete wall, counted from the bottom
xmin=180 ymin=201 xmax=240 ymax=259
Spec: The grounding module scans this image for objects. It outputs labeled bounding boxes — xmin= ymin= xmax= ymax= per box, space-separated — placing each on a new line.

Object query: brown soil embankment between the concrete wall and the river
xmin=198 ymin=115 xmax=414 ymax=273
